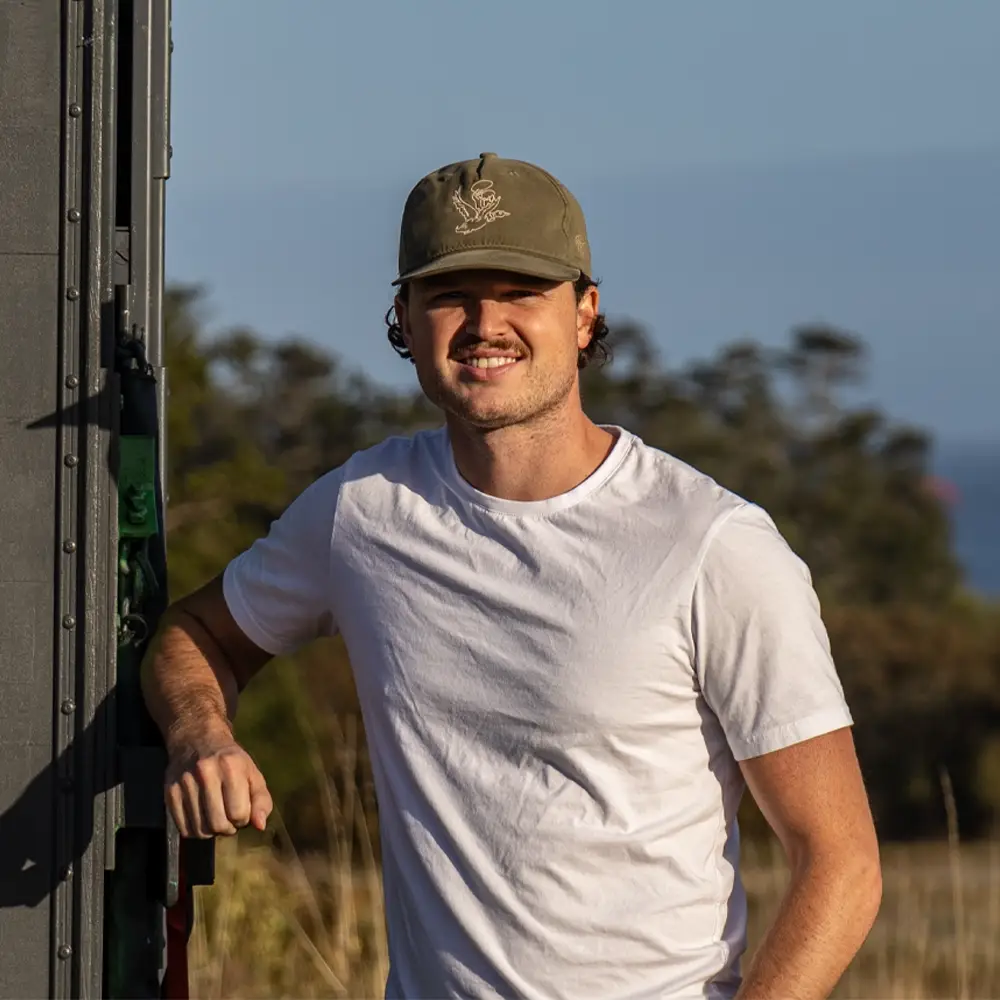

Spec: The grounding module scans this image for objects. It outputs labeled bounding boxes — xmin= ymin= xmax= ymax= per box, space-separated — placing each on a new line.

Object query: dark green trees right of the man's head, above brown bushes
xmin=584 ymin=327 xmax=959 ymax=604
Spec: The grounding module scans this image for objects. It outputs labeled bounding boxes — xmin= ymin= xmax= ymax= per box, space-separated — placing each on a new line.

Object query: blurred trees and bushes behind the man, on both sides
xmin=165 ymin=287 xmax=1000 ymax=846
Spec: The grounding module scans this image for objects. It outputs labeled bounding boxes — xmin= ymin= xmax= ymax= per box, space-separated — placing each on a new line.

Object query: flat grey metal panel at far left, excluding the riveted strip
xmin=0 ymin=0 xmax=71 ymax=998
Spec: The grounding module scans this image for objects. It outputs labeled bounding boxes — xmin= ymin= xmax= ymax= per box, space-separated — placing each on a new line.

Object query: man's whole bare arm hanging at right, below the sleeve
xmin=737 ymin=729 xmax=882 ymax=1000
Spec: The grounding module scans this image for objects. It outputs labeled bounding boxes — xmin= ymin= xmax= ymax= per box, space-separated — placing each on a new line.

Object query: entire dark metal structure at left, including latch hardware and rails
xmin=0 ymin=0 xmax=183 ymax=1000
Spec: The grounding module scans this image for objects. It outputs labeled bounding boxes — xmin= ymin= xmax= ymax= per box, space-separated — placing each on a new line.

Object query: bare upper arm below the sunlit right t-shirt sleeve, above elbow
xmin=740 ymin=727 xmax=878 ymax=866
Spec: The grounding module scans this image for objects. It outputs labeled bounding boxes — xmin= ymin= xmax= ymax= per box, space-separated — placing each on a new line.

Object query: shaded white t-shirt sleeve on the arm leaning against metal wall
xmin=222 ymin=469 xmax=342 ymax=655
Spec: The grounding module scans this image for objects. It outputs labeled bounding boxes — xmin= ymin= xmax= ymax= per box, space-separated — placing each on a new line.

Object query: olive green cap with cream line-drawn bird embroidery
xmin=393 ymin=153 xmax=591 ymax=285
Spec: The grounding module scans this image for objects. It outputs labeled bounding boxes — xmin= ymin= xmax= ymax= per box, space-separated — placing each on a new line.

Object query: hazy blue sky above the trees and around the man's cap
xmin=167 ymin=0 xmax=1000 ymax=443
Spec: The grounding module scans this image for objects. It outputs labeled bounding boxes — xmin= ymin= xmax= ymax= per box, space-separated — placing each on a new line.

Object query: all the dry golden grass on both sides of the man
xmin=190 ymin=725 xmax=1000 ymax=1000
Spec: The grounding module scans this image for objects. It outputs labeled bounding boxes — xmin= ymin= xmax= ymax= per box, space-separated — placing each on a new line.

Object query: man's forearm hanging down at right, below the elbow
xmin=737 ymin=859 xmax=881 ymax=1000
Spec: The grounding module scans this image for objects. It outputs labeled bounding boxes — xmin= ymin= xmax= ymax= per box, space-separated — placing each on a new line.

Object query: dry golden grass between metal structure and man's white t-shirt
xmin=189 ymin=720 xmax=388 ymax=998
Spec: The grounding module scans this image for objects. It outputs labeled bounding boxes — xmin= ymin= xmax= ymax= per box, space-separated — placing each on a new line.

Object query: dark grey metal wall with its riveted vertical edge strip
xmin=0 ymin=0 xmax=115 ymax=998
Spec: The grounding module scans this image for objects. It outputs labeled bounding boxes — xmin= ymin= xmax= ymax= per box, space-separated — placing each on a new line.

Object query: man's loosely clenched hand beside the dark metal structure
xmin=165 ymin=737 xmax=274 ymax=840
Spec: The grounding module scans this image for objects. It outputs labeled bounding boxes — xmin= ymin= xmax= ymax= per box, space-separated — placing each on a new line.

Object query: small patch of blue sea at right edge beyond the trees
xmin=934 ymin=443 xmax=1000 ymax=597
